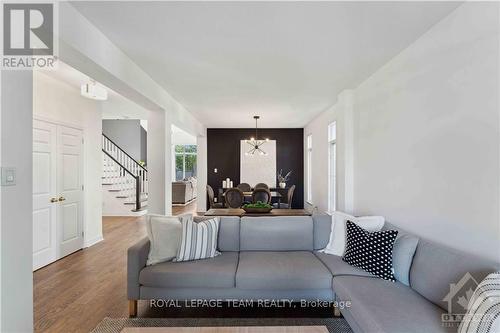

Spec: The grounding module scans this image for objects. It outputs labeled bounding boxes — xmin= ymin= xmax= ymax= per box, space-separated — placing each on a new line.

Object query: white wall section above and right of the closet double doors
xmin=33 ymin=71 xmax=102 ymax=246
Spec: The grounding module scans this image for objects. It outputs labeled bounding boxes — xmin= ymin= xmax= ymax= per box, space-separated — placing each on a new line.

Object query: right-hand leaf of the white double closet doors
xmin=57 ymin=126 xmax=83 ymax=258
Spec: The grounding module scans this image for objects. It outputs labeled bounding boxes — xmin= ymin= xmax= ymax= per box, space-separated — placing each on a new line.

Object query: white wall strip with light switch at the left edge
xmin=0 ymin=70 xmax=33 ymax=333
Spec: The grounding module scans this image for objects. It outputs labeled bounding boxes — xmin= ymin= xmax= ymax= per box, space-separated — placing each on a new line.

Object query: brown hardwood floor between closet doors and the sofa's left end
xmin=34 ymin=217 xmax=146 ymax=332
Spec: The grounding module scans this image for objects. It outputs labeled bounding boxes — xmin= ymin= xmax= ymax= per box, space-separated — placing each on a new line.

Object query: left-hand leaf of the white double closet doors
xmin=33 ymin=120 xmax=58 ymax=270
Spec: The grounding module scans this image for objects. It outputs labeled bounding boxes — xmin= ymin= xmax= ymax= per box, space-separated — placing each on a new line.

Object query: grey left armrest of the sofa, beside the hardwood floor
xmin=127 ymin=237 xmax=150 ymax=300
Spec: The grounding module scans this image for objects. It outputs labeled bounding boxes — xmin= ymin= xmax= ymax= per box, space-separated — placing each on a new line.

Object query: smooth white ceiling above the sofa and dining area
xmin=73 ymin=1 xmax=459 ymax=127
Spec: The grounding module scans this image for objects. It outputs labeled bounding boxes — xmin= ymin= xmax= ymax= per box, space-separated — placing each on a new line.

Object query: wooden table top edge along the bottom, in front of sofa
xmin=121 ymin=326 xmax=328 ymax=333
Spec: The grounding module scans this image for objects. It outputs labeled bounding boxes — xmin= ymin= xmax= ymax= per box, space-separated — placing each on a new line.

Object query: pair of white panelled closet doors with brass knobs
xmin=33 ymin=120 xmax=83 ymax=270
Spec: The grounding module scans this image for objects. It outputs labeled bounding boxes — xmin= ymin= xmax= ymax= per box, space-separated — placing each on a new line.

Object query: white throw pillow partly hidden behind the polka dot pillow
xmin=321 ymin=212 xmax=385 ymax=256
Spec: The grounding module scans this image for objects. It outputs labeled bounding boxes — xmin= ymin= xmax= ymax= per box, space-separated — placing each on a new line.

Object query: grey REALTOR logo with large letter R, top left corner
xmin=2 ymin=2 xmax=57 ymax=69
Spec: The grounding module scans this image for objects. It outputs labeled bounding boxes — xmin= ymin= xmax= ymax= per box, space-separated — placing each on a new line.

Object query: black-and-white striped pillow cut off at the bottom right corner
xmin=458 ymin=272 xmax=500 ymax=333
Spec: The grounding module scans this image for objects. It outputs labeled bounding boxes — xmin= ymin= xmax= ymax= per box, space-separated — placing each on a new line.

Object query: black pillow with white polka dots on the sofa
xmin=342 ymin=221 xmax=398 ymax=281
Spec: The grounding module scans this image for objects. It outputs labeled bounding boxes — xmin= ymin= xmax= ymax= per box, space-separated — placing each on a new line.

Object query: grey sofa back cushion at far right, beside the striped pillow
xmin=410 ymin=239 xmax=499 ymax=313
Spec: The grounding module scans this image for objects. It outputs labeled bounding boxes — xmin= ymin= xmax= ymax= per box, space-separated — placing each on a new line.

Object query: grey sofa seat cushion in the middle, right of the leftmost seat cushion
xmin=236 ymin=251 xmax=332 ymax=290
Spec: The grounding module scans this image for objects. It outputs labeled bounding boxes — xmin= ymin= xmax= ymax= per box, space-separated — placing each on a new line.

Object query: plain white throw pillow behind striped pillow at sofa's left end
xmin=146 ymin=215 xmax=192 ymax=266
